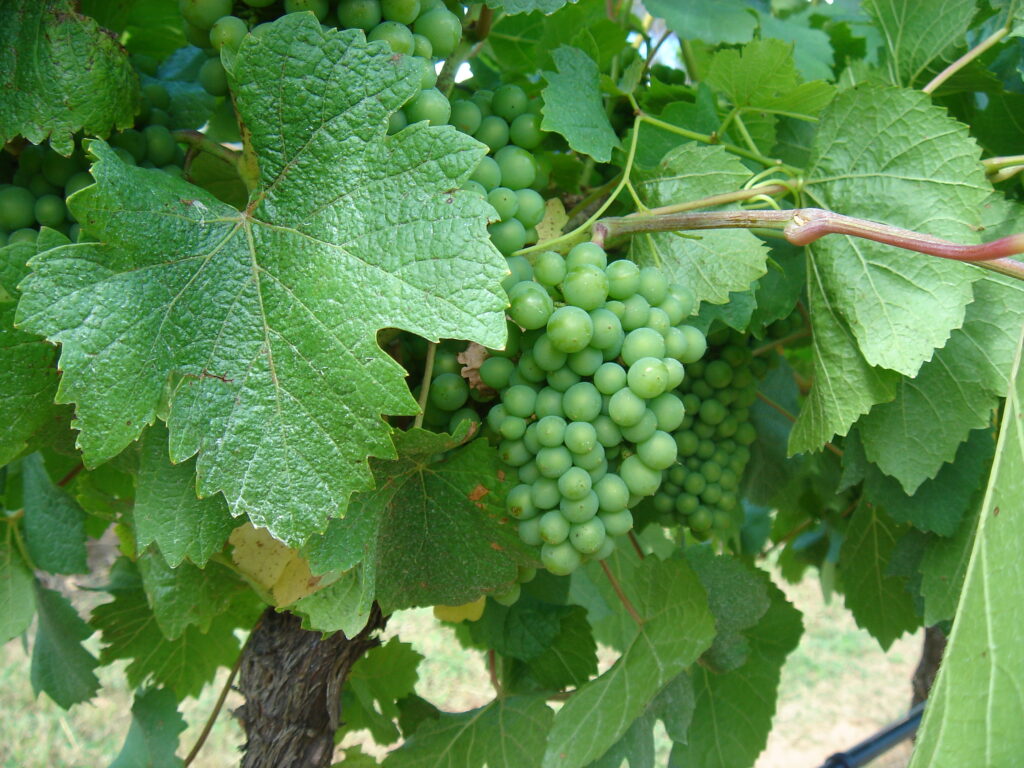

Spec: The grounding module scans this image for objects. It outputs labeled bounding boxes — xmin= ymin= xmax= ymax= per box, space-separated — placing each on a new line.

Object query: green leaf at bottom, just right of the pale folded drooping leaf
xmin=669 ymin=574 xmax=803 ymax=768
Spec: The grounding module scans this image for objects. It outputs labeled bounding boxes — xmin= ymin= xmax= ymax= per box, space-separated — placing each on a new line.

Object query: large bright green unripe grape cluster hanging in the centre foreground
xmin=479 ymin=243 xmax=706 ymax=574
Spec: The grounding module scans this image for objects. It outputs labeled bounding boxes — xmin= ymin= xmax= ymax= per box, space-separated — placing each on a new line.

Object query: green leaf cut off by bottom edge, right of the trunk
xmin=384 ymin=696 xmax=552 ymax=768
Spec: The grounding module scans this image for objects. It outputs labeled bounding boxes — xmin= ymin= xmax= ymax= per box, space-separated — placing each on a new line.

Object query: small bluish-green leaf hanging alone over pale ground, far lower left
xmin=31 ymin=582 xmax=99 ymax=710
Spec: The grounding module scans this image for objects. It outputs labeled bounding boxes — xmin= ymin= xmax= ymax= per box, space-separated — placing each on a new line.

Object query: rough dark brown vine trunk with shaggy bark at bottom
xmin=234 ymin=604 xmax=387 ymax=768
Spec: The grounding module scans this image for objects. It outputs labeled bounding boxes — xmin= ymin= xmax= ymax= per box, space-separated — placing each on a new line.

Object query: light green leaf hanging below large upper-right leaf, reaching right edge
xmin=860 ymin=272 xmax=1024 ymax=494
